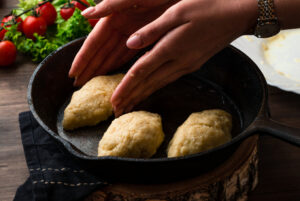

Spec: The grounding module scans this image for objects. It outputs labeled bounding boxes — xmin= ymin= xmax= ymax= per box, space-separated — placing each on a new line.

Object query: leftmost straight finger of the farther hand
xmin=69 ymin=18 xmax=113 ymax=77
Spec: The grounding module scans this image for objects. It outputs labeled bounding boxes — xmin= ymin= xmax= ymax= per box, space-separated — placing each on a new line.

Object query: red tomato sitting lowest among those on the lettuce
xmin=23 ymin=16 xmax=47 ymax=39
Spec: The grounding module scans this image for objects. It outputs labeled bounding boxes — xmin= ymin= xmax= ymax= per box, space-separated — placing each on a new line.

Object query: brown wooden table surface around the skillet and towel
xmin=0 ymin=0 xmax=300 ymax=201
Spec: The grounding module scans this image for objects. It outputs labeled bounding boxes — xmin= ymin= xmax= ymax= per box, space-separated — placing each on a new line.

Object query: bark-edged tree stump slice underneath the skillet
xmin=85 ymin=136 xmax=258 ymax=201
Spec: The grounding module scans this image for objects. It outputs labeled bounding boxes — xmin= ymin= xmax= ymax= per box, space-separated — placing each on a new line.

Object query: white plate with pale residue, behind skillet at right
xmin=231 ymin=29 xmax=300 ymax=94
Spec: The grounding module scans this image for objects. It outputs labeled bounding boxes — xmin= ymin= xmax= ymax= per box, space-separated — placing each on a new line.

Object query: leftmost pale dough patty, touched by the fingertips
xmin=63 ymin=74 xmax=124 ymax=130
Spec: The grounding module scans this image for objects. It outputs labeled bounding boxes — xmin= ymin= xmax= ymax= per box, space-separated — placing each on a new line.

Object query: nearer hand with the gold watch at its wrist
xmin=105 ymin=0 xmax=258 ymax=116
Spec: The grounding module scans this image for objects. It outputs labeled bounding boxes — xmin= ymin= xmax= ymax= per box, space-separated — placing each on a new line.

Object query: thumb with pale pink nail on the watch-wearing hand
xmin=126 ymin=6 xmax=187 ymax=49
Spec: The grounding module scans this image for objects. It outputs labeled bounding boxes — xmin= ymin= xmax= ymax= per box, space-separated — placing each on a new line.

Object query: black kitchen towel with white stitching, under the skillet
xmin=14 ymin=112 xmax=107 ymax=201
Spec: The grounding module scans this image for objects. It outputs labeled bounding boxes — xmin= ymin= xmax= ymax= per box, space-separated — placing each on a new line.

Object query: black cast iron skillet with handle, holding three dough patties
xmin=28 ymin=38 xmax=300 ymax=182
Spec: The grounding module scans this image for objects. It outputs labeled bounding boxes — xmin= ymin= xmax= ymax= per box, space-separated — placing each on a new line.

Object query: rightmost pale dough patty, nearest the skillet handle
xmin=167 ymin=109 xmax=232 ymax=157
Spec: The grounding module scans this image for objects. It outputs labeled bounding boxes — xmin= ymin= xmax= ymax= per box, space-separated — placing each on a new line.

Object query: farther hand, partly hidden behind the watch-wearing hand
xmin=69 ymin=0 xmax=177 ymax=86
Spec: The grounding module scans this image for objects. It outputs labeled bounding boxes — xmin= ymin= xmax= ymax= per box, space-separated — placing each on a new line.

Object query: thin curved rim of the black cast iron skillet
xmin=27 ymin=36 xmax=268 ymax=163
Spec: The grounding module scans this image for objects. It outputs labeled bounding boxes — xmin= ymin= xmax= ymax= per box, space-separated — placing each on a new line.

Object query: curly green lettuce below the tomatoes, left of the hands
xmin=5 ymin=5 xmax=92 ymax=62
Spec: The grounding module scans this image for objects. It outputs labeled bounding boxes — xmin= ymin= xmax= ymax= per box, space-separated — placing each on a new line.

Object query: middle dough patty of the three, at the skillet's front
xmin=98 ymin=111 xmax=164 ymax=158
